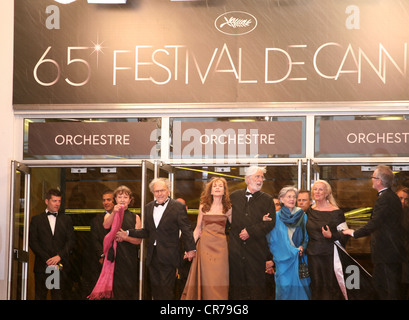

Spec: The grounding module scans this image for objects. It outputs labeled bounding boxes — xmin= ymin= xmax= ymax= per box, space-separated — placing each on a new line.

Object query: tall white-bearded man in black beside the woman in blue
xmin=229 ymin=167 xmax=276 ymax=300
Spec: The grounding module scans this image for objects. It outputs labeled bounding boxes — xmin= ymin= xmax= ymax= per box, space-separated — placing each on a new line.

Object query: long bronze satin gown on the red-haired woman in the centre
xmin=181 ymin=214 xmax=229 ymax=300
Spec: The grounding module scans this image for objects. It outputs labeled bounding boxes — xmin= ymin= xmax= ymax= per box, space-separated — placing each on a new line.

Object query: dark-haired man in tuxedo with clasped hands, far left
xmin=29 ymin=189 xmax=75 ymax=300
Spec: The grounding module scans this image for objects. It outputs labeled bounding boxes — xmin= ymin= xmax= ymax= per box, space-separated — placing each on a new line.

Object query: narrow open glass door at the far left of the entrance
xmin=8 ymin=161 xmax=30 ymax=300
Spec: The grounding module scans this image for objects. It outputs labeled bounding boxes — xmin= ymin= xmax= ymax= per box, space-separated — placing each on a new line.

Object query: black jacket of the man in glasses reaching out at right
xmin=354 ymin=189 xmax=404 ymax=263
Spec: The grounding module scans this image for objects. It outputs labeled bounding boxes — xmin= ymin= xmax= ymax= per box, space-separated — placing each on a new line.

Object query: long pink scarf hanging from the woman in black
xmin=88 ymin=207 xmax=124 ymax=300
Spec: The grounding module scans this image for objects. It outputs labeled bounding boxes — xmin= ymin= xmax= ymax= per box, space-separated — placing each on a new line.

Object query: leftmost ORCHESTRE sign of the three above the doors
xmin=28 ymin=122 xmax=158 ymax=157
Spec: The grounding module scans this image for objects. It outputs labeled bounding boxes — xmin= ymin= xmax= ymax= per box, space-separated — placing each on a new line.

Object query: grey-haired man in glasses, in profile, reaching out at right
xmin=343 ymin=166 xmax=404 ymax=300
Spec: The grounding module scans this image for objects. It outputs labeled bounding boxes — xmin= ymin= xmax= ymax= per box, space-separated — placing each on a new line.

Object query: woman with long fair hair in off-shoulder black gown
xmin=307 ymin=180 xmax=348 ymax=300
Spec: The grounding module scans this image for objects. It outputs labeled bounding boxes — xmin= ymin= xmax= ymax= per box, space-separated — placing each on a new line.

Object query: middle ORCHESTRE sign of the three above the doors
xmin=173 ymin=121 xmax=303 ymax=161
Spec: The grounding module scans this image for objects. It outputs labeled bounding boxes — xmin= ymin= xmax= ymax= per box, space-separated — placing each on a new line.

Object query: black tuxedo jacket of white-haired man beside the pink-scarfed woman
xmin=129 ymin=199 xmax=196 ymax=268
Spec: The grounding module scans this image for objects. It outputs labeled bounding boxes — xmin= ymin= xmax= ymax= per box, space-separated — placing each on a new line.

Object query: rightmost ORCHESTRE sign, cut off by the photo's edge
xmin=318 ymin=120 xmax=409 ymax=157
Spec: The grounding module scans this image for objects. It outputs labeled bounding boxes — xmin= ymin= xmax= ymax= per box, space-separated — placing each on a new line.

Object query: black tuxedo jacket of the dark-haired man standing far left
xmin=29 ymin=211 xmax=75 ymax=273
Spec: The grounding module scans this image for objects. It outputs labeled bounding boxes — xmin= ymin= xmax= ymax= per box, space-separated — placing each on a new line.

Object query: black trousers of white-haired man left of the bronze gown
xmin=149 ymin=248 xmax=176 ymax=300
